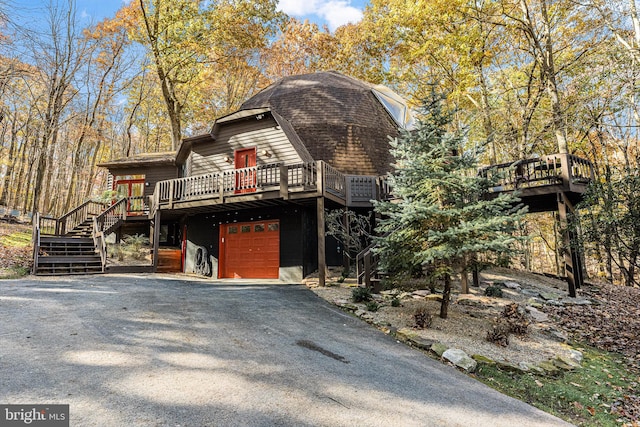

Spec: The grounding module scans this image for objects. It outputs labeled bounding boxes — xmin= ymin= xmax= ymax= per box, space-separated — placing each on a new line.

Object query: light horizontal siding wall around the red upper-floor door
xmin=187 ymin=115 xmax=302 ymax=175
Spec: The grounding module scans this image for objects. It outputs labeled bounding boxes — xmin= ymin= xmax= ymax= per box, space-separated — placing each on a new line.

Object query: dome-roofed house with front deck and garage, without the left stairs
xmin=101 ymin=72 xmax=410 ymax=281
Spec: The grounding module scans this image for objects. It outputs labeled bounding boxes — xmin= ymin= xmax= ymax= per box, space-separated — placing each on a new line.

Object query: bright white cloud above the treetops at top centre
xmin=278 ymin=0 xmax=362 ymax=31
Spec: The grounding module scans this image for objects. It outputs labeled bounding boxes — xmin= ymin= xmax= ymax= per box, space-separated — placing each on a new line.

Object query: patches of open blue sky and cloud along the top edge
xmin=8 ymin=0 xmax=367 ymax=31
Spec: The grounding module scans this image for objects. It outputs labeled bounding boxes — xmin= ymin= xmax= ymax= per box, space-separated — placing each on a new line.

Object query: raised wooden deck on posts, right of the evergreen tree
xmin=480 ymin=154 xmax=593 ymax=212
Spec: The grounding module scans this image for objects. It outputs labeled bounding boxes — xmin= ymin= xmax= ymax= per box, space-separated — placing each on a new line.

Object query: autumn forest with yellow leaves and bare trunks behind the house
xmin=0 ymin=0 xmax=640 ymax=285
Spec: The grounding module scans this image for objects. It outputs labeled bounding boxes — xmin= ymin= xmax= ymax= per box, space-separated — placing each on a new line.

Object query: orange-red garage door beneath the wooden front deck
xmin=219 ymin=220 xmax=280 ymax=279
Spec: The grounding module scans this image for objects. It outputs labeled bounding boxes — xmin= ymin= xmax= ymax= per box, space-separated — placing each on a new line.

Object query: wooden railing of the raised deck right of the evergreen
xmin=479 ymin=154 xmax=593 ymax=191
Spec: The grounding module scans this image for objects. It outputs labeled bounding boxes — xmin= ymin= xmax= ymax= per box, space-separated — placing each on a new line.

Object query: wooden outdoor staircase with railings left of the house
xmin=33 ymin=199 xmax=127 ymax=276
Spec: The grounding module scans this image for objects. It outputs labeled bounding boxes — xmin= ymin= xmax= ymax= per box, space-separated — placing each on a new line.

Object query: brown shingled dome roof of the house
xmin=241 ymin=72 xmax=398 ymax=175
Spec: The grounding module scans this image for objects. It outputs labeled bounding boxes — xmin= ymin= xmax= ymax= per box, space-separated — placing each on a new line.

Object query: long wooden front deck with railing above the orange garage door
xmin=150 ymin=161 xmax=385 ymax=216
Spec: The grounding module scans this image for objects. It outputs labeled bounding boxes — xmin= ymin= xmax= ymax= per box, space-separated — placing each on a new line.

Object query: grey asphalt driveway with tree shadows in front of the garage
xmin=0 ymin=275 xmax=566 ymax=427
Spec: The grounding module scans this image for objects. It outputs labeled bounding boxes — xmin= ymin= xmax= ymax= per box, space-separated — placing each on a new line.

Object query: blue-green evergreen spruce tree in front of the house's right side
xmin=376 ymin=94 xmax=526 ymax=318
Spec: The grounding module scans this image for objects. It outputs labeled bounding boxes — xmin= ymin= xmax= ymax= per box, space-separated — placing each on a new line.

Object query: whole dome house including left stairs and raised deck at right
xmin=34 ymin=72 xmax=593 ymax=296
